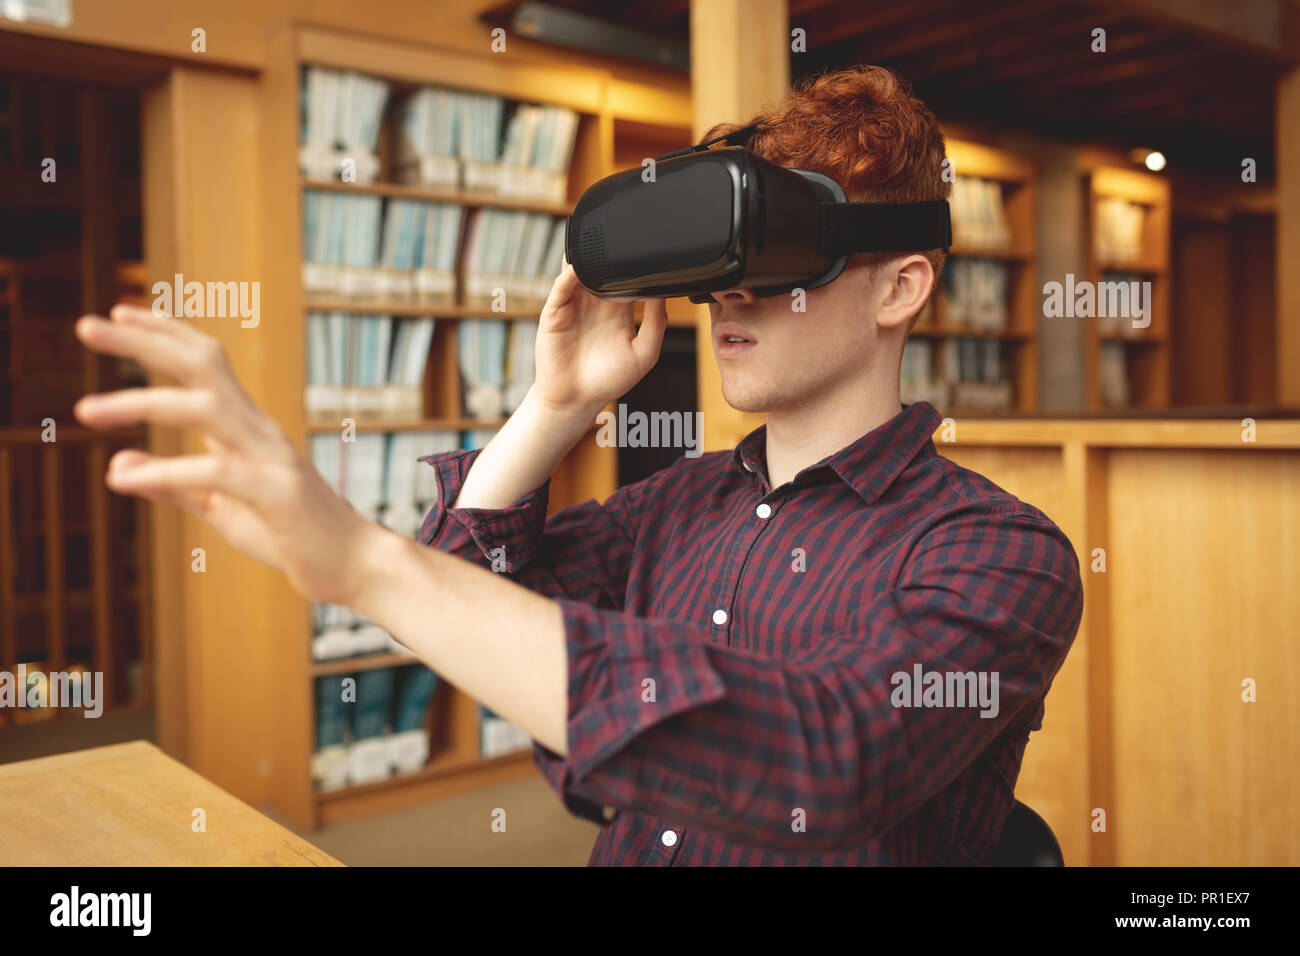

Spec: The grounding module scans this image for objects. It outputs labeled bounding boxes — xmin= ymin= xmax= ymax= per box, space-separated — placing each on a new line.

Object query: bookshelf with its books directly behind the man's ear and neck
xmin=902 ymin=135 xmax=1039 ymax=416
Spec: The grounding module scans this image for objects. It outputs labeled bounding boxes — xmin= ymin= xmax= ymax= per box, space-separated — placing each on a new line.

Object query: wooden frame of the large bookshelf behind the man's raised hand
xmin=260 ymin=25 xmax=693 ymax=827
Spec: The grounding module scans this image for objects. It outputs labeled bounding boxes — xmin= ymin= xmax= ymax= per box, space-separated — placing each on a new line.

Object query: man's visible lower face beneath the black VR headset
xmin=709 ymin=265 xmax=897 ymax=412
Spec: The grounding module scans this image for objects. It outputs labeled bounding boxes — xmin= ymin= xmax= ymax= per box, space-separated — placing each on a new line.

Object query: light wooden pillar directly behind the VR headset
xmin=690 ymin=0 xmax=790 ymax=451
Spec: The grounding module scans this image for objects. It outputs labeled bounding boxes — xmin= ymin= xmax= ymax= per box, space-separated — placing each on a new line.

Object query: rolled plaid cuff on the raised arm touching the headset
xmin=420 ymin=449 xmax=551 ymax=572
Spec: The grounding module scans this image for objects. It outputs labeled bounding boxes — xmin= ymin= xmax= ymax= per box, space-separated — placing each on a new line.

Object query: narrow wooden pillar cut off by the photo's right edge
xmin=1274 ymin=68 xmax=1300 ymax=406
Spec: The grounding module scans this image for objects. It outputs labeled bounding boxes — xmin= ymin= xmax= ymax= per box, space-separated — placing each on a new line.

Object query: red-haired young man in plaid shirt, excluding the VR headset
xmin=77 ymin=68 xmax=1082 ymax=865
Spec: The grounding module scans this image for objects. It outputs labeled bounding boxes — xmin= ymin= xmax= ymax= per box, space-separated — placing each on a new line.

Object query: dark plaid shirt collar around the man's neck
xmin=732 ymin=402 xmax=943 ymax=505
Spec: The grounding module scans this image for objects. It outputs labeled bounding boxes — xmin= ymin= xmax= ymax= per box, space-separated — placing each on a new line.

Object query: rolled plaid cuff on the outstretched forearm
xmin=533 ymin=598 xmax=727 ymax=825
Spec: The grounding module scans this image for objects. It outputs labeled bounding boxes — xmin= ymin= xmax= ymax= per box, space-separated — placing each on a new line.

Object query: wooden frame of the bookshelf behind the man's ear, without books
xmin=911 ymin=135 xmax=1040 ymax=418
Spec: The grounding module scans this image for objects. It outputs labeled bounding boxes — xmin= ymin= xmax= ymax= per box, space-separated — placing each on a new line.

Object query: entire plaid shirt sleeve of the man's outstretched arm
xmin=537 ymin=506 xmax=1083 ymax=852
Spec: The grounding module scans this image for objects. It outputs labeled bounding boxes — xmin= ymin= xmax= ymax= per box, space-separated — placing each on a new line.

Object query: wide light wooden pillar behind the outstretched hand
xmin=142 ymin=65 xmax=291 ymax=805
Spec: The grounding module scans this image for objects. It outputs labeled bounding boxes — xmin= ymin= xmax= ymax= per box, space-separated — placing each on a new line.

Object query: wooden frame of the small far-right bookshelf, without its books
xmin=1083 ymin=162 xmax=1173 ymax=408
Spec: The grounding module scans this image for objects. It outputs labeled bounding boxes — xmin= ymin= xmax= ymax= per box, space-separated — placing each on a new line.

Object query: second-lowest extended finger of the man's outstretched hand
xmin=73 ymin=386 xmax=261 ymax=450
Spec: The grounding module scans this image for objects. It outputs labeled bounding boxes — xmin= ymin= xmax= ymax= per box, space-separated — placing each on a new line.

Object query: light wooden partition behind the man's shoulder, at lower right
xmin=935 ymin=420 xmax=1300 ymax=866
